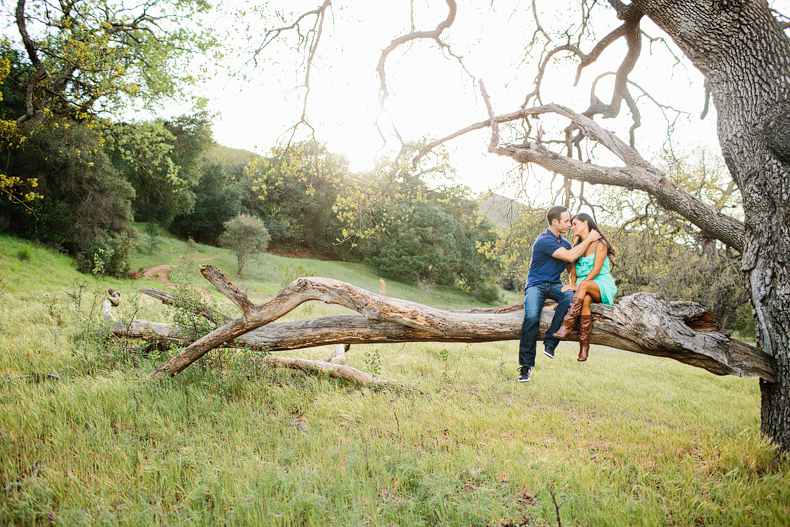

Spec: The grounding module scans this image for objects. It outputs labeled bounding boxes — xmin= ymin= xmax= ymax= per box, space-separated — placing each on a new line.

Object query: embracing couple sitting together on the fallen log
xmin=518 ymin=205 xmax=617 ymax=382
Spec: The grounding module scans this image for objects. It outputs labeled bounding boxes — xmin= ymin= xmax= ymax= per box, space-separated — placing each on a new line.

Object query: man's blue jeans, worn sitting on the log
xmin=518 ymin=282 xmax=573 ymax=368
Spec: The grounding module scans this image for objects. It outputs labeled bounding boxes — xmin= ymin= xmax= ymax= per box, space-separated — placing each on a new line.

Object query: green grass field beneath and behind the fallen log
xmin=0 ymin=236 xmax=790 ymax=526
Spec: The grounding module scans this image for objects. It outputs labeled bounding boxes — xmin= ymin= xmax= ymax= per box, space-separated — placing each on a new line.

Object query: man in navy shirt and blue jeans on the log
xmin=518 ymin=205 xmax=601 ymax=382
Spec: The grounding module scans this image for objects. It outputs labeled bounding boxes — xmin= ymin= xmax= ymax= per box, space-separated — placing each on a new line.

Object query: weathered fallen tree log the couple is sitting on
xmin=106 ymin=265 xmax=774 ymax=382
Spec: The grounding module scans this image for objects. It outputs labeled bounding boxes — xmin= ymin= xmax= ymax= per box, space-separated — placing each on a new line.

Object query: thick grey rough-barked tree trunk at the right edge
xmin=633 ymin=0 xmax=790 ymax=458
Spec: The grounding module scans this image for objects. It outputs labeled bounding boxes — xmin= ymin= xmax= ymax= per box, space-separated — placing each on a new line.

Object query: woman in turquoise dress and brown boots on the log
xmin=554 ymin=212 xmax=617 ymax=361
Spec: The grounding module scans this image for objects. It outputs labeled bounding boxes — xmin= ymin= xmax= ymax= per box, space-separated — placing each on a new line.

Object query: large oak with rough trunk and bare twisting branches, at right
xmin=241 ymin=0 xmax=790 ymax=450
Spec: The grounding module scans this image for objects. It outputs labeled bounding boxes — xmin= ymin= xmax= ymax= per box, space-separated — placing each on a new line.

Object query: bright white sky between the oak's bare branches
xmin=203 ymin=0 xmax=716 ymax=199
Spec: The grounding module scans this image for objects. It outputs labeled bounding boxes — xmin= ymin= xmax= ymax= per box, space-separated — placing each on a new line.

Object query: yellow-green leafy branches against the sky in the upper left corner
xmin=0 ymin=0 xmax=217 ymax=204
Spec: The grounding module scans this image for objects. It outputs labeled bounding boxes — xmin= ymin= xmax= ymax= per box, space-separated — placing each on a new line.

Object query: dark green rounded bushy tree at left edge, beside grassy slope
xmin=0 ymin=120 xmax=137 ymax=276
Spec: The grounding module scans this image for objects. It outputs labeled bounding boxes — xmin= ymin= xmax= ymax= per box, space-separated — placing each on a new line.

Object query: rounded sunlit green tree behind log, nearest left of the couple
xmin=336 ymin=151 xmax=499 ymax=303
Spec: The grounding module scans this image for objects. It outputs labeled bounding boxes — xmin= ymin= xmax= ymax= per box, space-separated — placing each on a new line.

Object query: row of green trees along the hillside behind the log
xmin=0 ymin=47 xmax=499 ymax=302
